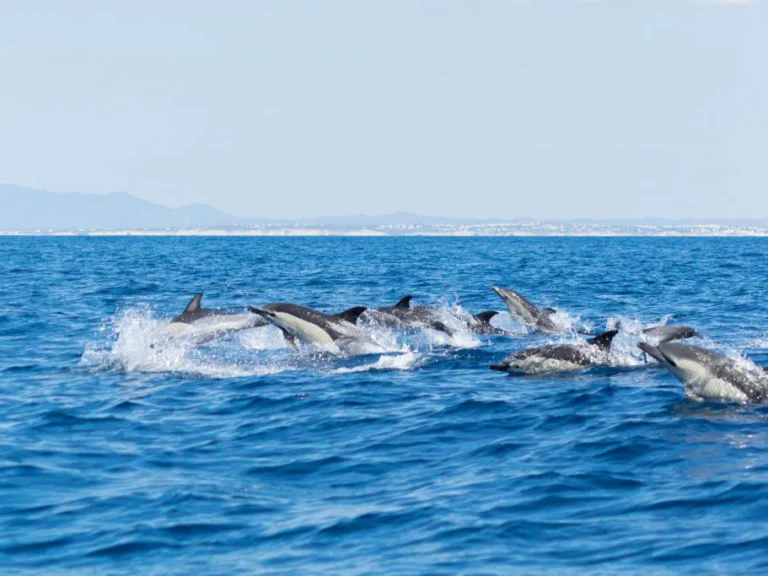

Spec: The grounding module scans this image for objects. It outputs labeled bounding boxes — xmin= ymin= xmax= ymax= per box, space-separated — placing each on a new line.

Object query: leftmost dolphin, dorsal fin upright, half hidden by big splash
xmin=168 ymin=292 xmax=268 ymax=339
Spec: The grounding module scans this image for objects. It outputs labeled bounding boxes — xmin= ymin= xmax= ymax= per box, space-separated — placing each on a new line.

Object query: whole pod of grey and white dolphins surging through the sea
xmin=162 ymin=286 xmax=768 ymax=403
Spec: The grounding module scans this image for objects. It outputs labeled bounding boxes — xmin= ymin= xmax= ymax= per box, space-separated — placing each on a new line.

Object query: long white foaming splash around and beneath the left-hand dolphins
xmin=80 ymin=307 xmax=460 ymax=378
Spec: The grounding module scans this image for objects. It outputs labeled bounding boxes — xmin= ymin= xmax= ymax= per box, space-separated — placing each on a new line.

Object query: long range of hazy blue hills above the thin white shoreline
xmin=0 ymin=184 xmax=768 ymax=234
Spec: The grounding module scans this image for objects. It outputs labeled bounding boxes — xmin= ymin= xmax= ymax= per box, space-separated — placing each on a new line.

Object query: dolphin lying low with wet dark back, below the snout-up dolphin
xmin=491 ymin=330 xmax=619 ymax=375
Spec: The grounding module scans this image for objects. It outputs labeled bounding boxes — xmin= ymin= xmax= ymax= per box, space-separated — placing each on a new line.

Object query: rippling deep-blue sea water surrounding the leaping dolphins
xmin=0 ymin=238 xmax=768 ymax=574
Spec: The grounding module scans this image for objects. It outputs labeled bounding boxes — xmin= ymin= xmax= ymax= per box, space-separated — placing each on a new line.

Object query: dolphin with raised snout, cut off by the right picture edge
xmin=638 ymin=342 xmax=768 ymax=404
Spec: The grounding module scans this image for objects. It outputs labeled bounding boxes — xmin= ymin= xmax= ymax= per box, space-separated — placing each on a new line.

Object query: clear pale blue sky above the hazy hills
xmin=0 ymin=0 xmax=768 ymax=218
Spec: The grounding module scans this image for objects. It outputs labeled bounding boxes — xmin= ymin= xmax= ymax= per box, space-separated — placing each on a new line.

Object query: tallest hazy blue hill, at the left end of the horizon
xmin=0 ymin=184 xmax=238 ymax=230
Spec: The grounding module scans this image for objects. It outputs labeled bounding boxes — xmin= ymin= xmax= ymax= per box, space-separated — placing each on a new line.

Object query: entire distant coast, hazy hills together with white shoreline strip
xmin=0 ymin=184 xmax=768 ymax=237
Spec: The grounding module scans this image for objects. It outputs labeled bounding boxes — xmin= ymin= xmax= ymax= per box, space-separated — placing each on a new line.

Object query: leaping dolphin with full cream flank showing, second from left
xmin=248 ymin=302 xmax=386 ymax=356
